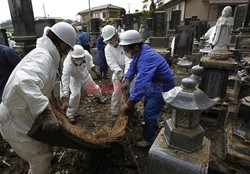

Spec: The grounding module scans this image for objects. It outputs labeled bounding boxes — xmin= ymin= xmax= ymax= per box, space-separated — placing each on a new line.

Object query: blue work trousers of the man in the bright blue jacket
xmin=143 ymin=95 xmax=165 ymax=143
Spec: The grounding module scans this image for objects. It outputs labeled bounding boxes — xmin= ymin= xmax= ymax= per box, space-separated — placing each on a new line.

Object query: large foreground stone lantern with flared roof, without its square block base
xmin=163 ymin=78 xmax=216 ymax=153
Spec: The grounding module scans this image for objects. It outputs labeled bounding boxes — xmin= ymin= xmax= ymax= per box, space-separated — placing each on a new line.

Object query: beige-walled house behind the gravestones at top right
xmin=157 ymin=0 xmax=248 ymax=22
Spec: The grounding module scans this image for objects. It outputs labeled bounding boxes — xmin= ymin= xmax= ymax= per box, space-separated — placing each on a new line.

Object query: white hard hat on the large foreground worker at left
xmin=51 ymin=22 xmax=76 ymax=48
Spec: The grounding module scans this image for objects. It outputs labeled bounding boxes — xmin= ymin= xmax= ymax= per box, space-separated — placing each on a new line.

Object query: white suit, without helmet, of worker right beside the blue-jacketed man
xmin=105 ymin=44 xmax=132 ymax=115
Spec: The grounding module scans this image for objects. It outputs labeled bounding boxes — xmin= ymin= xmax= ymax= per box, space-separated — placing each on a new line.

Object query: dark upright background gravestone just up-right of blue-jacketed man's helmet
xmin=153 ymin=11 xmax=166 ymax=37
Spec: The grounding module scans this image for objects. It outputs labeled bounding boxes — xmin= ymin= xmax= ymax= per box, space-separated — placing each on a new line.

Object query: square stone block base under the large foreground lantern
xmin=147 ymin=128 xmax=210 ymax=174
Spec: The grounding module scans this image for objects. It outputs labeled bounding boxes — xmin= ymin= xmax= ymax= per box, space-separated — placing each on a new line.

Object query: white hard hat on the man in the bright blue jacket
xmin=119 ymin=30 xmax=141 ymax=45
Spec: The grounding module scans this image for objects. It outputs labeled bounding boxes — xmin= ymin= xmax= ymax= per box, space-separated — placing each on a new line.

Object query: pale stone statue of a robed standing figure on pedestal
xmin=211 ymin=6 xmax=234 ymax=59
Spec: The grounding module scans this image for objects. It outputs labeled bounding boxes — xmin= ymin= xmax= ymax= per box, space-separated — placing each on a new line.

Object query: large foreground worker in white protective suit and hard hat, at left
xmin=0 ymin=22 xmax=76 ymax=174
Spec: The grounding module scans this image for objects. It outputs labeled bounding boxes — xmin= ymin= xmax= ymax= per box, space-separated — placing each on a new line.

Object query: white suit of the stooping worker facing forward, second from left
xmin=60 ymin=50 xmax=101 ymax=119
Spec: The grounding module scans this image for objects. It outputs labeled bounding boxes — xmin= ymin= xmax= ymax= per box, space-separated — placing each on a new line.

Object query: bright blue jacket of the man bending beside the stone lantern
xmin=126 ymin=44 xmax=175 ymax=102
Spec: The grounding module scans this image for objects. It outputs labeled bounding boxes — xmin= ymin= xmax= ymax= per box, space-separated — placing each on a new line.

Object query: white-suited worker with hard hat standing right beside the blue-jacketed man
xmin=102 ymin=25 xmax=131 ymax=118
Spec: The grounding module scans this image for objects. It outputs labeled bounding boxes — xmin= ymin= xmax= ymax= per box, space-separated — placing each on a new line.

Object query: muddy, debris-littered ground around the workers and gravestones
xmin=0 ymin=73 xmax=250 ymax=174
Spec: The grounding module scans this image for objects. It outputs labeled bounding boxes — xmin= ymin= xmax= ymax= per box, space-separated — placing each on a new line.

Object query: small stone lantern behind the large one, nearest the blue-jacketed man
xmin=175 ymin=56 xmax=192 ymax=86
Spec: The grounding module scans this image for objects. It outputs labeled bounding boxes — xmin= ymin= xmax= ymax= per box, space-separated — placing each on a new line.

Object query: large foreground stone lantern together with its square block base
xmin=147 ymin=78 xmax=215 ymax=174
